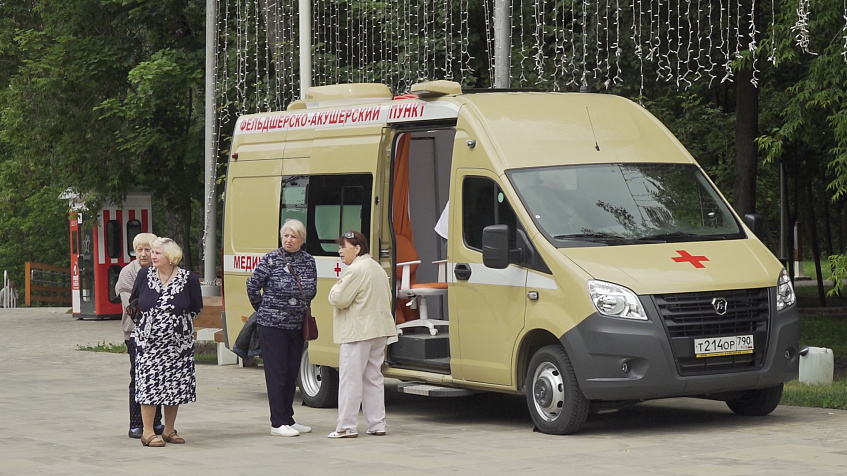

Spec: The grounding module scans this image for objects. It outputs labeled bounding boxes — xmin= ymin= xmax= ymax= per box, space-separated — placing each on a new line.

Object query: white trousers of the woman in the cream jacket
xmin=335 ymin=337 xmax=387 ymax=431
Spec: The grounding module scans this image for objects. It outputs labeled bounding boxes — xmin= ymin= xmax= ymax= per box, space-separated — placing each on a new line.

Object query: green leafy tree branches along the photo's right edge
xmin=759 ymin=1 xmax=847 ymax=293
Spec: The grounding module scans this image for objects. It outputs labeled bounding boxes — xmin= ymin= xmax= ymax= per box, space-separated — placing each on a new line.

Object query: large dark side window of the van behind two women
xmin=280 ymin=174 xmax=373 ymax=256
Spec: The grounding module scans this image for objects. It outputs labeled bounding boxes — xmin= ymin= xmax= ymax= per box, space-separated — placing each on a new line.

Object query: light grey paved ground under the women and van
xmin=0 ymin=309 xmax=847 ymax=476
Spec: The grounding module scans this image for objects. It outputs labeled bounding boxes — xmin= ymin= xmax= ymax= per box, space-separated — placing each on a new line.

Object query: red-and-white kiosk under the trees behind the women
xmin=65 ymin=193 xmax=152 ymax=319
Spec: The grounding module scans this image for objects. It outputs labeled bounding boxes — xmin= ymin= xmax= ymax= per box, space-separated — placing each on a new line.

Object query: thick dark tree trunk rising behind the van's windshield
xmin=732 ymin=66 xmax=759 ymax=217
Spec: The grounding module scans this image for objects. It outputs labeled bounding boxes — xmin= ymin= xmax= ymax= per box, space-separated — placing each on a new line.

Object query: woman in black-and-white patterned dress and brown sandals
xmin=130 ymin=238 xmax=203 ymax=447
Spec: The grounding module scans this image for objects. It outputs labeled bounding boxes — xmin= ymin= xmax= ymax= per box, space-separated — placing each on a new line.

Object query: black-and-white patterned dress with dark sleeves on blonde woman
xmin=131 ymin=266 xmax=203 ymax=405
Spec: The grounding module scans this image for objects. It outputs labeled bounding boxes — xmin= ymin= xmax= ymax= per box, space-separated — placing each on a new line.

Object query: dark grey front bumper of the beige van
xmin=560 ymin=290 xmax=800 ymax=401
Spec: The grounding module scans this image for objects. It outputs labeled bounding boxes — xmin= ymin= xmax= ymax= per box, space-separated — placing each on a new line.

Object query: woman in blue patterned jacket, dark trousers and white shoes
xmin=247 ymin=220 xmax=318 ymax=436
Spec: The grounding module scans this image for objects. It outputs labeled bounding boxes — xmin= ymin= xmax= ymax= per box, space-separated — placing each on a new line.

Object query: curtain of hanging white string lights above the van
xmin=217 ymin=0 xmax=847 ymax=116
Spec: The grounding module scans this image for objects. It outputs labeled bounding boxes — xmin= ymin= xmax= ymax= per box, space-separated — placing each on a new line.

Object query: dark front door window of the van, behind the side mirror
xmin=462 ymin=177 xmax=518 ymax=251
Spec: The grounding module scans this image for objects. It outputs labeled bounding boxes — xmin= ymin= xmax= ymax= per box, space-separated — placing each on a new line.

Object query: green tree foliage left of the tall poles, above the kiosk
xmin=0 ymin=0 xmax=205 ymax=277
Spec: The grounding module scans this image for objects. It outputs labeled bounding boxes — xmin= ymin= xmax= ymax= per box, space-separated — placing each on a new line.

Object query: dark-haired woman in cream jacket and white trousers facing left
xmin=329 ymin=231 xmax=397 ymax=438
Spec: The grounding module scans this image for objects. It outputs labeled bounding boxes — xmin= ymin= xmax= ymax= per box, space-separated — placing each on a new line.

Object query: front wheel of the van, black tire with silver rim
xmin=526 ymin=345 xmax=589 ymax=435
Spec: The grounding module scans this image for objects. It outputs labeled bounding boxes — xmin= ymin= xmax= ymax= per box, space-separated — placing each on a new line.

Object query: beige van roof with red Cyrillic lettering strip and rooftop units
xmin=233 ymin=81 xmax=694 ymax=170
